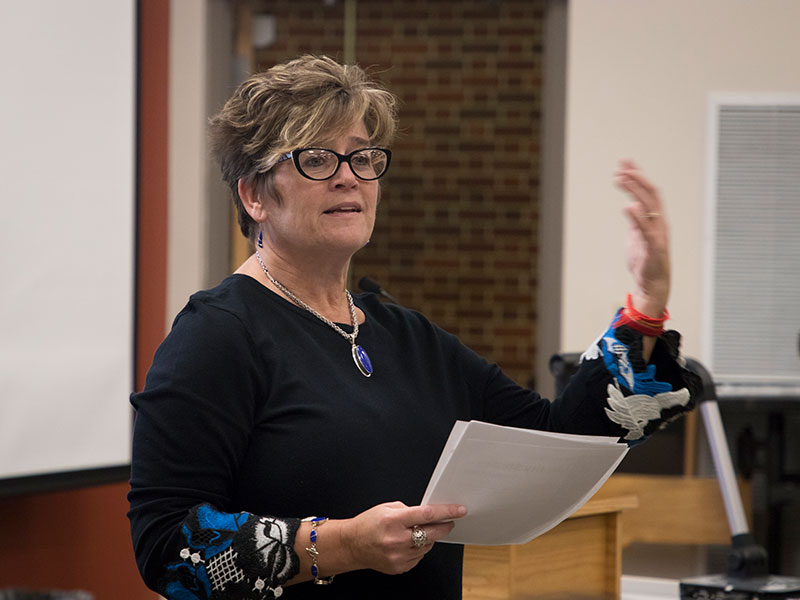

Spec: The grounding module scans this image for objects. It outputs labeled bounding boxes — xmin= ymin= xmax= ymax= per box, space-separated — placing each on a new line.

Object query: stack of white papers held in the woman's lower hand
xmin=422 ymin=421 xmax=628 ymax=545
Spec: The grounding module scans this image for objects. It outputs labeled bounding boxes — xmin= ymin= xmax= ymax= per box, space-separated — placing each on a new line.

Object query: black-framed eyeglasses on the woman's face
xmin=276 ymin=148 xmax=392 ymax=181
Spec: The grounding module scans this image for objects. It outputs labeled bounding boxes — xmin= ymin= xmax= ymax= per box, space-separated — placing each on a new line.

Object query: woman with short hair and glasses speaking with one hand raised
xmin=129 ymin=56 xmax=694 ymax=600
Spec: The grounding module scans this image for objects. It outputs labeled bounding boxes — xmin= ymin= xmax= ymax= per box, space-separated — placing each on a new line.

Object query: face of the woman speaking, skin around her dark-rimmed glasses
xmin=263 ymin=123 xmax=378 ymax=257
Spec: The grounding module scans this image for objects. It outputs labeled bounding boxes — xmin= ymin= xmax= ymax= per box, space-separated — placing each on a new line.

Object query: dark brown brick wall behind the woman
xmin=256 ymin=0 xmax=544 ymax=383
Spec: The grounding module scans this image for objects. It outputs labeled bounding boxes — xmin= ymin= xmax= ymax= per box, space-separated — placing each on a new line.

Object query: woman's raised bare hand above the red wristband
xmin=615 ymin=160 xmax=670 ymax=318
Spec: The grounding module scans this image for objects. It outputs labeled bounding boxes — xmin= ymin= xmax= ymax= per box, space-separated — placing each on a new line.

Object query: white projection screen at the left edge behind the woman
xmin=0 ymin=0 xmax=136 ymax=492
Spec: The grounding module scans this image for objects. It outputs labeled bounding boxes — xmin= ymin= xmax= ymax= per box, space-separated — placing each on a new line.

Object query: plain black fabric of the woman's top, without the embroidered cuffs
xmin=129 ymin=275 xmax=692 ymax=600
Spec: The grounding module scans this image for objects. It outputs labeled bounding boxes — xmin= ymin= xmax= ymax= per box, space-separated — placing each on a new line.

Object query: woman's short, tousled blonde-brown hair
xmin=209 ymin=55 xmax=397 ymax=240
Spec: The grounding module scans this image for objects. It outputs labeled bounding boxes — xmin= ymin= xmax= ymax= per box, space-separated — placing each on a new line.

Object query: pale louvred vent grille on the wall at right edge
xmin=711 ymin=103 xmax=800 ymax=387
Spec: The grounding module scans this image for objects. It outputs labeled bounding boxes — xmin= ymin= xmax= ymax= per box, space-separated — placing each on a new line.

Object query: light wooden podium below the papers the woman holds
xmin=463 ymin=496 xmax=638 ymax=600
